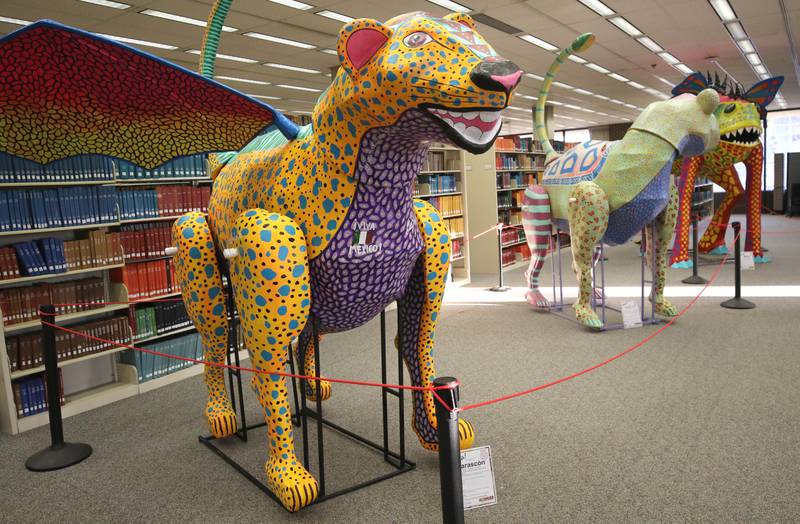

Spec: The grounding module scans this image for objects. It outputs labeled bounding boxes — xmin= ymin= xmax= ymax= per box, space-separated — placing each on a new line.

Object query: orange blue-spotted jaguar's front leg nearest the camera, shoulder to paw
xmin=227 ymin=209 xmax=319 ymax=511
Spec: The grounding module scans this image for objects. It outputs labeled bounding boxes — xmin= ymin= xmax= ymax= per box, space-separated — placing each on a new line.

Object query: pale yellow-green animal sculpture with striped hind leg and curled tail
xmin=522 ymin=34 xmax=719 ymax=328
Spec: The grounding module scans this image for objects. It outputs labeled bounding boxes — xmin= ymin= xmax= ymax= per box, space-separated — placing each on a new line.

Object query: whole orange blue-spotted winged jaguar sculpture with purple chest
xmin=0 ymin=7 xmax=522 ymax=511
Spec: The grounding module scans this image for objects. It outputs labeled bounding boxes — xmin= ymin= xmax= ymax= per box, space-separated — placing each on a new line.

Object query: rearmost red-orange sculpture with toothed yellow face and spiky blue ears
xmin=670 ymin=73 xmax=783 ymax=268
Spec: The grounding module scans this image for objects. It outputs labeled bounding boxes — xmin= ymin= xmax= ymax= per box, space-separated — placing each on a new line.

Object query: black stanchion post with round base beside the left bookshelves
xmin=25 ymin=304 xmax=92 ymax=471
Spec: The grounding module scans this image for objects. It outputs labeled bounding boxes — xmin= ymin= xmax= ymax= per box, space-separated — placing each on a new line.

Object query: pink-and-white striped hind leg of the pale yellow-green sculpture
xmin=522 ymin=186 xmax=552 ymax=309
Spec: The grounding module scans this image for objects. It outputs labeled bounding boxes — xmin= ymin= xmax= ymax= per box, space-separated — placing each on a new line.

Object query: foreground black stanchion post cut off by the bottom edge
xmin=433 ymin=377 xmax=464 ymax=524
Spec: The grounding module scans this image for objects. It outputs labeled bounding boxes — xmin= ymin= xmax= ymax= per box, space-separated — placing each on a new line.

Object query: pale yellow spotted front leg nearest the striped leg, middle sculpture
xmin=567 ymin=182 xmax=608 ymax=328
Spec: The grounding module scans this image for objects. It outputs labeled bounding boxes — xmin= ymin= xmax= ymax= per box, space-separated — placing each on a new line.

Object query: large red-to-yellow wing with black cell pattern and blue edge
xmin=0 ymin=20 xmax=297 ymax=169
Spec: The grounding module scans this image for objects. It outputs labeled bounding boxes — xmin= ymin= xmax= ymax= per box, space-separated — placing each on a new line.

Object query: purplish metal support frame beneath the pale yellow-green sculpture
xmin=550 ymin=222 xmax=661 ymax=331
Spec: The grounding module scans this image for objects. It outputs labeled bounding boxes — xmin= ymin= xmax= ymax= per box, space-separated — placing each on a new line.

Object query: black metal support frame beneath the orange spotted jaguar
xmin=198 ymin=308 xmax=416 ymax=507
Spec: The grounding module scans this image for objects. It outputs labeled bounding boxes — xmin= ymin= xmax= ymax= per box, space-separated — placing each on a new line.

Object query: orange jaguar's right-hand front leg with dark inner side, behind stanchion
xmin=398 ymin=200 xmax=475 ymax=451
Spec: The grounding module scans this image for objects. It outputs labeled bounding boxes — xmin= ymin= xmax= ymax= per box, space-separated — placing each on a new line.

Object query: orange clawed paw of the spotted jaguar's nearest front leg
xmin=264 ymin=453 xmax=319 ymax=513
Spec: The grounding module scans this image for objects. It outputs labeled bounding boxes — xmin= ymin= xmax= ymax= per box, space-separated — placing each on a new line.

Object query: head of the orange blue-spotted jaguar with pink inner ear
xmin=334 ymin=12 xmax=522 ymax=153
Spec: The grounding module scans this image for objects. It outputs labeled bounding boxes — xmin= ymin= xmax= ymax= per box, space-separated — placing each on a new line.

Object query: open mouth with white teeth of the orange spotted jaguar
xmin=427 ymin=107 xmax=502 ymax=152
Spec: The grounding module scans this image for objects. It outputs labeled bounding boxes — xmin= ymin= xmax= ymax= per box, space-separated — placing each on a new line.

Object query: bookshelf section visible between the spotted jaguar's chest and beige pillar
xmin=414 ymin=144 xmax=469 ymax=284
